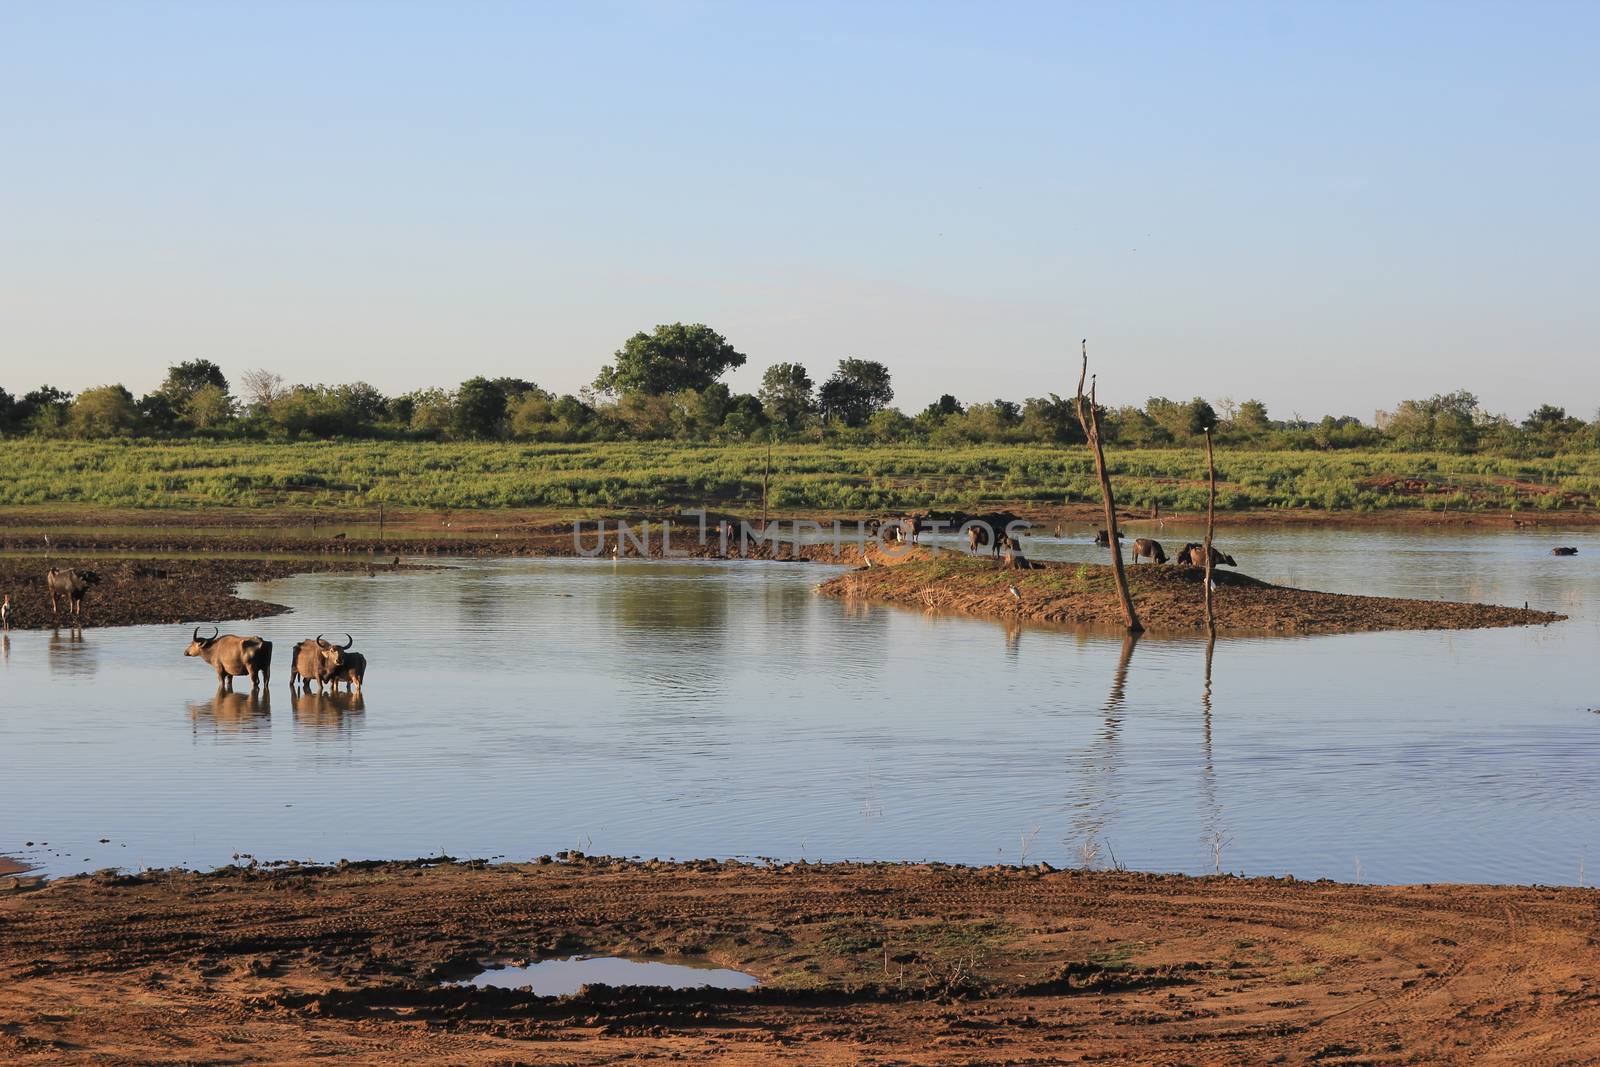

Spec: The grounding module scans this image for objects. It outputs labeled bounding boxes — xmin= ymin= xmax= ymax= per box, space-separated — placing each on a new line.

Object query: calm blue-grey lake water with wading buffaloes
xmin=0 ymin=526 xmax=1600 ymax=885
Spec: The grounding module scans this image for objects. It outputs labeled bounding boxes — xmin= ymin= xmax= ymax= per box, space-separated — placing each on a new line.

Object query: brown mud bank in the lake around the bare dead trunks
xmin=818 ymin=549 xmax=1566 ymax=633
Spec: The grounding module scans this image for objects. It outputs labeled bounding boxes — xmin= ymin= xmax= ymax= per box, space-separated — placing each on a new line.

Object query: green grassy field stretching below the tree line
xmin=0 ymin=440 xmax=1600 ymax=510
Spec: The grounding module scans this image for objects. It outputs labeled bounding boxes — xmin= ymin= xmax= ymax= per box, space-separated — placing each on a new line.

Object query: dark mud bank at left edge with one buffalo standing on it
xmin=0 ymin=557 xmax=425 ymax=630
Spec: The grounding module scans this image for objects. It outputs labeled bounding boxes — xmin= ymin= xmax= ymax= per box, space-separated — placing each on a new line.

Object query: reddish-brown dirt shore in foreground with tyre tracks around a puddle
xmin=0 ymin=856 xmax=1600 ymax=1065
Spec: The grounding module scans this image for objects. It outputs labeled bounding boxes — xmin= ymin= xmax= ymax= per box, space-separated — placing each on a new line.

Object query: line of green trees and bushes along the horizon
xmin=0 ymin=323 xmax=1600 ymax=456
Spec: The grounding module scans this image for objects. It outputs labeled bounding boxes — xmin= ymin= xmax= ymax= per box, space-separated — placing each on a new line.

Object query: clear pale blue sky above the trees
xmin=0 ymin=0 xmax=1600 ymax=419
